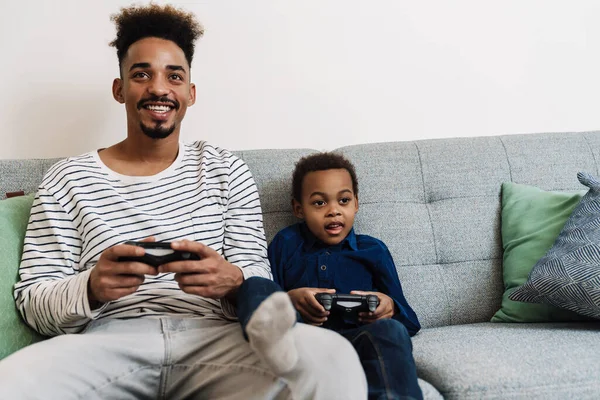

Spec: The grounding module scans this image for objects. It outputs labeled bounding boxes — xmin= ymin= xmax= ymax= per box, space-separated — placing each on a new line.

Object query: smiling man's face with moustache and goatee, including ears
xmin=113 ymin=37 xmax=196 ymax=139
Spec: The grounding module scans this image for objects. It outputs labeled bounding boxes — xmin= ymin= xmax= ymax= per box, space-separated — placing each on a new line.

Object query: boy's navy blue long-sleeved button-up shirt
xmin=269 ymin=222 xmax=421 ymax=336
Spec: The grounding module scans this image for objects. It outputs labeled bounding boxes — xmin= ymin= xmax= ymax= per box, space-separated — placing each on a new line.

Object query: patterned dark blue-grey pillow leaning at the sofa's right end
xmin=509 ymin=172 xmax=600 ymax=319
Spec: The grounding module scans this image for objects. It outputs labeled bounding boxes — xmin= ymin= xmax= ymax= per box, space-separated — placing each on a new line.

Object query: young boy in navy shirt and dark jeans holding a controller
xmin=241 ymin=153 xmax=422 ymax=399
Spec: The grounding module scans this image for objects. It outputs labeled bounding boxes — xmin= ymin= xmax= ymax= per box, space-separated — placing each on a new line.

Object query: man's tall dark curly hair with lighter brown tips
xmin=110 ymin=4 xmax=204 ymax=70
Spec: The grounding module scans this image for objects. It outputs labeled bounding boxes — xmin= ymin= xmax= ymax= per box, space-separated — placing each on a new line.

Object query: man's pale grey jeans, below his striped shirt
xmin=0 ymin=318 xmax=367 ymax=400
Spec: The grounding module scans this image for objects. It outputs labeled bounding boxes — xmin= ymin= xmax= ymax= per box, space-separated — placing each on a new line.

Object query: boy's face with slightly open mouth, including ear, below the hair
xmin=292 ymin=169 xmax=358 ymax=245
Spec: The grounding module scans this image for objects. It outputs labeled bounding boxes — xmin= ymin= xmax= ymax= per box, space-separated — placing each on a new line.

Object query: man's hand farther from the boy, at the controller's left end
xmin=88 ymin=238 xmax=157 ymax=309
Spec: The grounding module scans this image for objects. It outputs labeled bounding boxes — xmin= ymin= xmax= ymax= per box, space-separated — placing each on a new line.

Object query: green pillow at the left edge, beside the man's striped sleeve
xmin=0 ymin=195 xmax=43 ymax=360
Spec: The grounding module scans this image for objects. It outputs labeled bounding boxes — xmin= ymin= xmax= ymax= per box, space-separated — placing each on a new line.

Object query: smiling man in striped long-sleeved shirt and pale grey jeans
xmin=0 ymin=5 xmax=366 ymax=399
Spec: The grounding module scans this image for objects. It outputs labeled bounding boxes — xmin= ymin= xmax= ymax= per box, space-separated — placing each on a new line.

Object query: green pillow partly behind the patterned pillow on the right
xmin=492 ymin=182 xmax=585 ymax=322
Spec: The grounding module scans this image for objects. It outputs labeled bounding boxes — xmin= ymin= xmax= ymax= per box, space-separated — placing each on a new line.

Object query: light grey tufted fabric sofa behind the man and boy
xmin=0 ymin=132 xmax=600 ymax=399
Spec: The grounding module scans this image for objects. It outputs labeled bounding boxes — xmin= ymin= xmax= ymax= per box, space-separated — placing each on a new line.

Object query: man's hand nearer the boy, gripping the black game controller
xmin=158 ymin=240 xmax=244 ymax=299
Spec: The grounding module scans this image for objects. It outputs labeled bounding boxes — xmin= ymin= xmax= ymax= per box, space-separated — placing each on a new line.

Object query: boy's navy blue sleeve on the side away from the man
xmin=373 ymin=242 xmax=421 ymax=336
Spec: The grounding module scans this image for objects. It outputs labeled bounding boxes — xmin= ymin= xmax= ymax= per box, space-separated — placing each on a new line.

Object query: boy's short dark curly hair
xmin=292 ymin=152 xmax=358 ymax=202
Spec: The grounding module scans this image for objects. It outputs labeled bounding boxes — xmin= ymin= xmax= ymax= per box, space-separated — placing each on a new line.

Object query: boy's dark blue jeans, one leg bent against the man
xmin=236 ymin=277 xmax=423 ymax=400
